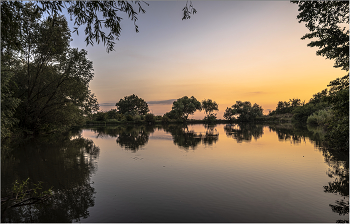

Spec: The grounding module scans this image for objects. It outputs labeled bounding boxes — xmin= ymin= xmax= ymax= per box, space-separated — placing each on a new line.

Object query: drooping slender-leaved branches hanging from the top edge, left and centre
xmin=1 ymin=1 xmax=197 ymax=52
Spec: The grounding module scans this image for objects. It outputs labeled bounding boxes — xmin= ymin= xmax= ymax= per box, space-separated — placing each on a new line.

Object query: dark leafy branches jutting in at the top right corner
xmin=292 ymin=1 xmax=349 ymax=71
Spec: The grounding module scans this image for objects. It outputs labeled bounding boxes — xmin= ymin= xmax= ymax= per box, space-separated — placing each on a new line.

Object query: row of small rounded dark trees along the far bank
xmin=91 ymin=94 xmax=263 ymax=123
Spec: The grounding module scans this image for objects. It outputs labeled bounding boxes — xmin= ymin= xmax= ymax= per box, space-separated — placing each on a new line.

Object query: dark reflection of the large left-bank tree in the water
xmin=1 ymin=130 xmax=100 ymax=222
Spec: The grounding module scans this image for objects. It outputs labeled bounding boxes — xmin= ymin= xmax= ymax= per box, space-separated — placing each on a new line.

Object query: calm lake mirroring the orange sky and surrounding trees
xmin=1 ymin=124 xmax=349 ymax=223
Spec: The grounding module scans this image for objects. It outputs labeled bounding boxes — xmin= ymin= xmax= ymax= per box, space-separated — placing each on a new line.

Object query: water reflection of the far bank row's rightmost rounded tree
xmin=224 ymin=123 xmax=264 ymax=143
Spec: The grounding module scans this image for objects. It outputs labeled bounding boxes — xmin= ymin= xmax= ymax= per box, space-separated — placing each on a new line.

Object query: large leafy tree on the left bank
xmin=1 ymin=8 xmax=98 ymax=135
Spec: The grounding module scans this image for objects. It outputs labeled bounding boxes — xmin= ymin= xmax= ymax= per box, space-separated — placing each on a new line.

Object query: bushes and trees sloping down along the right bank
xmin=269 ymin=74 xmax=349 ymax=151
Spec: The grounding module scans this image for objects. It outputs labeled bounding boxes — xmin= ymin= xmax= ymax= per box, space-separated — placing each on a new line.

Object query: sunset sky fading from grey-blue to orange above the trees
xmin=68 ymin=1 xmax=346 ymax=119
